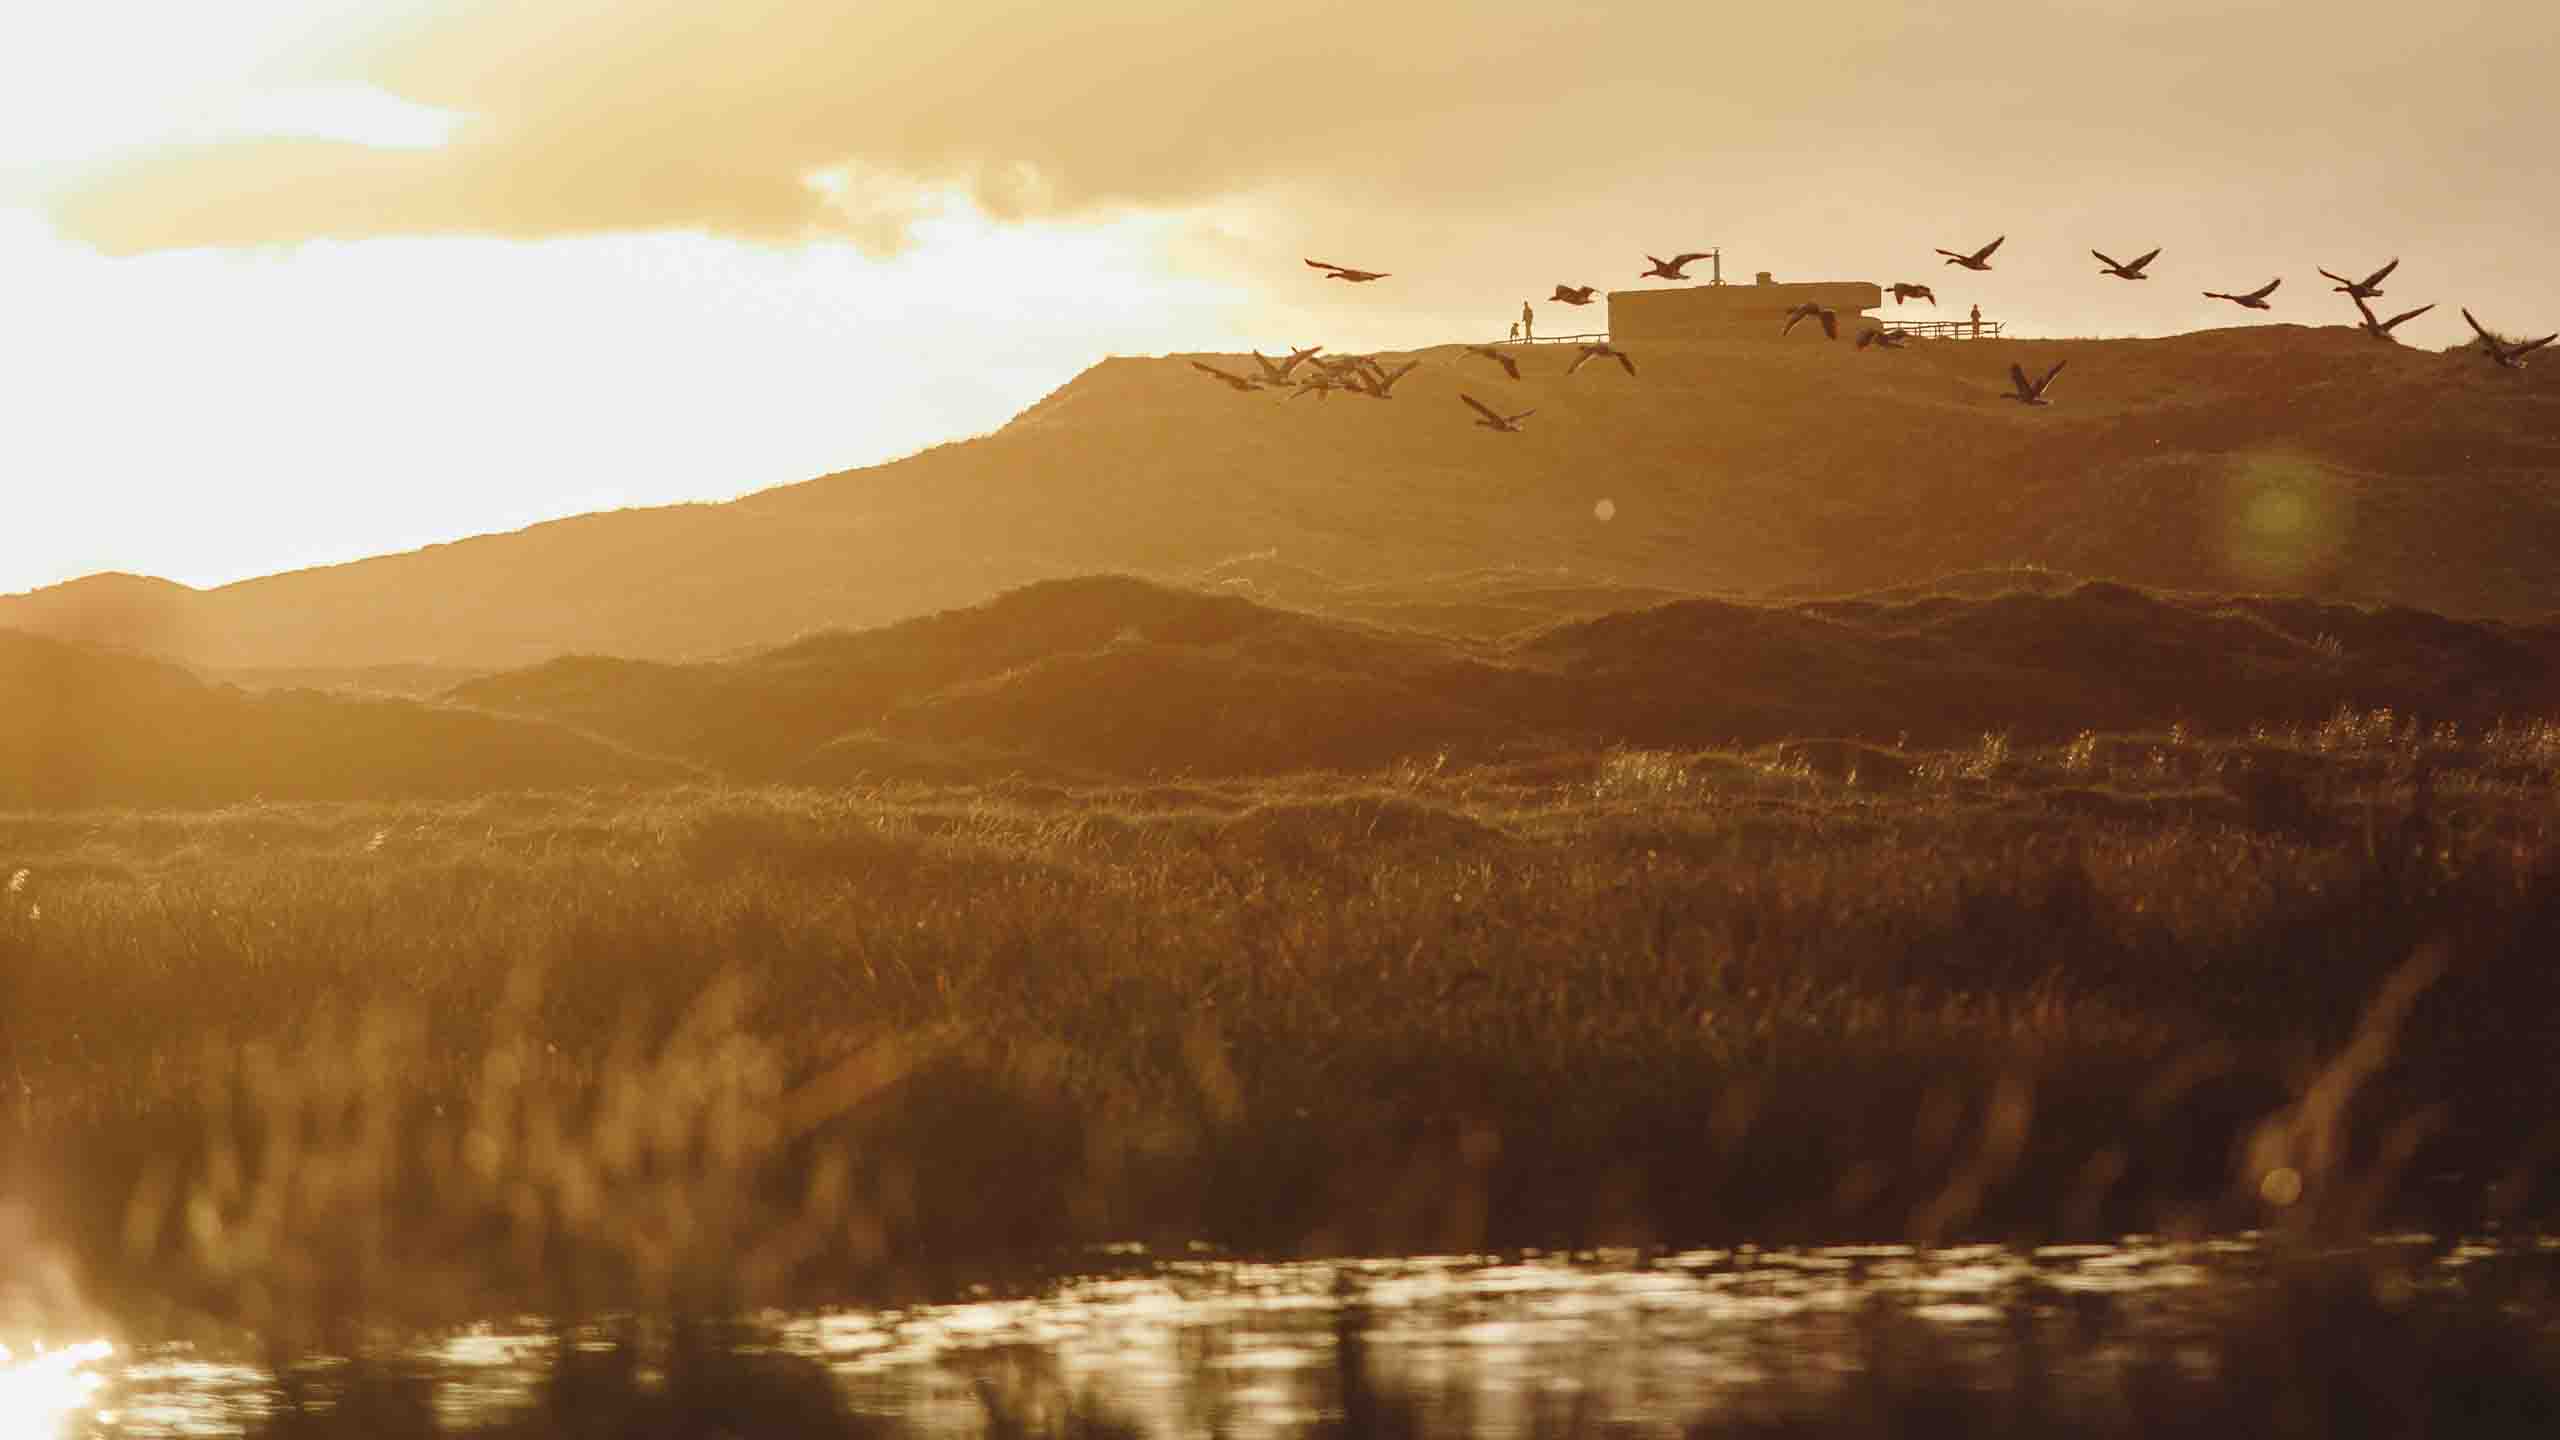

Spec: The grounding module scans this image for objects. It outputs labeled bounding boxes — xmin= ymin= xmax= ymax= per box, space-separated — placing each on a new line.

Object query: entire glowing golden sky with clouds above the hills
xmin=0 ymin=0 xmax=2560 ymax=589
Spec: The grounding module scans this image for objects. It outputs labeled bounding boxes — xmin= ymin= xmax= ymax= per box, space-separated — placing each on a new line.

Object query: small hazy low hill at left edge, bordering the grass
xmin=0 ymin=630 xmax=691 ymax=810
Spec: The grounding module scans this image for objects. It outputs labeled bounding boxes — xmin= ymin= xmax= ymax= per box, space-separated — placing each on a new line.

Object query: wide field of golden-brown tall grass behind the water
xmin=0 ymin=725 xmax=2560 ymax=1343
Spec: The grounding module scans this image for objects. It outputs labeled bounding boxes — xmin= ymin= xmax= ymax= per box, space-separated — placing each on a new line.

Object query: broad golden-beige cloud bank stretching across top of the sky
xmin=35 ymin=0 xmax=2560 ymax=269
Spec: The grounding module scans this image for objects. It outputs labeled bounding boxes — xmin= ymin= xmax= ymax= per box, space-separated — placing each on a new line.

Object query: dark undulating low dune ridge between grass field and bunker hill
xmin=453 ymin=577 xmax=2560 ymax=784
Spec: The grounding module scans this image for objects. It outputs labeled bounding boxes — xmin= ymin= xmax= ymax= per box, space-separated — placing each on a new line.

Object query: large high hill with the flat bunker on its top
xmin=0 ymin=325 xmax=2560 ymax=671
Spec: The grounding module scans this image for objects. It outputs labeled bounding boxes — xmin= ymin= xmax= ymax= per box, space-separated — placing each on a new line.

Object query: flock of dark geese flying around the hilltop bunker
xmin=1190 ymin=236 xmax=2560 ymax=436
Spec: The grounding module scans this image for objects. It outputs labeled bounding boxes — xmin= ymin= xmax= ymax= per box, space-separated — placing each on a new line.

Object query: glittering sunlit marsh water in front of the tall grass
xmin=64 ymin=1235 xmax=2560 ymax=1440
